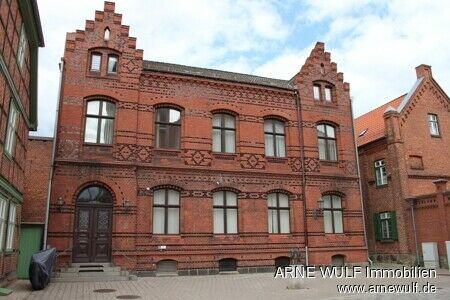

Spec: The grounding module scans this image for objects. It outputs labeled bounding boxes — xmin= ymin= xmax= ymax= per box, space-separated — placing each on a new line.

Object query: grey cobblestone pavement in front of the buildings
xmin=0 ymin=272 xmax=450 ymax=300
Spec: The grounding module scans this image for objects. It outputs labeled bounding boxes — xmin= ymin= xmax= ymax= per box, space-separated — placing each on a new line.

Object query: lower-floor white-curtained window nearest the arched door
xmin=153 ymin=189 xmax=180 ymax=234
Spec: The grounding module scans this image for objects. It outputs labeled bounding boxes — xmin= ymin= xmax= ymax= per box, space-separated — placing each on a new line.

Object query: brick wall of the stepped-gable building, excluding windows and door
xmin=48 ymin=2 xmax=367 ymax=274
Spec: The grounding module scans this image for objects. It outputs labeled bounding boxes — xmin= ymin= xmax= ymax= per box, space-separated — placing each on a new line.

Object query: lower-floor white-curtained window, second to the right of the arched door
xmin=213 ymin=191 xmax=238 ymax=234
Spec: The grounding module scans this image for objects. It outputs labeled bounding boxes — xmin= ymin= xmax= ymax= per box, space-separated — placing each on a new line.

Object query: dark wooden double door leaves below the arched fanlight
xmin=73 ymin=204 xmax=112 ymax=262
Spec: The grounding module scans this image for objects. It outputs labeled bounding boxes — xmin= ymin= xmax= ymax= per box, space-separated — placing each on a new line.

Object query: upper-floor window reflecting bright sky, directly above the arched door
xmin=84 ymin=100 xmax=116 ymax=145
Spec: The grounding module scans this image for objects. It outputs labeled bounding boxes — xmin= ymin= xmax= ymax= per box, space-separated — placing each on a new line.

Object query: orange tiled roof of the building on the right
xmin=355 ymin=94 xmax=406 ymax=147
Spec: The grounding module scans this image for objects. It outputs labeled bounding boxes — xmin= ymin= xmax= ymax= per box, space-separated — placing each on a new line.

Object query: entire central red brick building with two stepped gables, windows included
xmin=48 ymin=2 xmax=367 ymax=274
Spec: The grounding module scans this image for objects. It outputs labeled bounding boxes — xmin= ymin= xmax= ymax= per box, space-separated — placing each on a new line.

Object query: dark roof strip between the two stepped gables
xmin=143 ymin=60 xmax=294 ymax=90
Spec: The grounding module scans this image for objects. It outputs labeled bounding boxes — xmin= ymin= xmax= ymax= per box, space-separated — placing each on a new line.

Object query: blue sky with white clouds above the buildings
xmin=32 ymin=0 xmax=450 ymax=136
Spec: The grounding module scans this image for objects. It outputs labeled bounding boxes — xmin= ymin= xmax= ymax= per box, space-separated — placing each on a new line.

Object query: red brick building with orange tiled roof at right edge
xmin=355 ymin=65 xmax=450 ymax=266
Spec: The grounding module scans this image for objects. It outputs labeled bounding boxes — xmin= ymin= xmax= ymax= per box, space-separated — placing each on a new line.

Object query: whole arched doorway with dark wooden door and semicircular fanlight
xmin=73 ymin=185 xmax=113 ymax=262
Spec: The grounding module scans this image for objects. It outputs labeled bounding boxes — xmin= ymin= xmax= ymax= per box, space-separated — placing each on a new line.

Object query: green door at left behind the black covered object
xmin=17 ymin=225 xmax=42 ymax=279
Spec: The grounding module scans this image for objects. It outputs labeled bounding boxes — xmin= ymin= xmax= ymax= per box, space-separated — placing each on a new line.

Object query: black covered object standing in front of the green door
xmin=30 ymin=248 xmax=56 ymax=290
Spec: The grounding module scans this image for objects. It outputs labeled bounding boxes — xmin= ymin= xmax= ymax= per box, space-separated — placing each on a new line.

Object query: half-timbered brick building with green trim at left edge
xmin=0 ymin=0 xmax=44 ymax=284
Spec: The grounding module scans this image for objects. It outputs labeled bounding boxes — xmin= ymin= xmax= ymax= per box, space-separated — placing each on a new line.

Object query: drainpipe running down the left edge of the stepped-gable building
xmin=43 ymin=58 xmax=64 ymax=249
